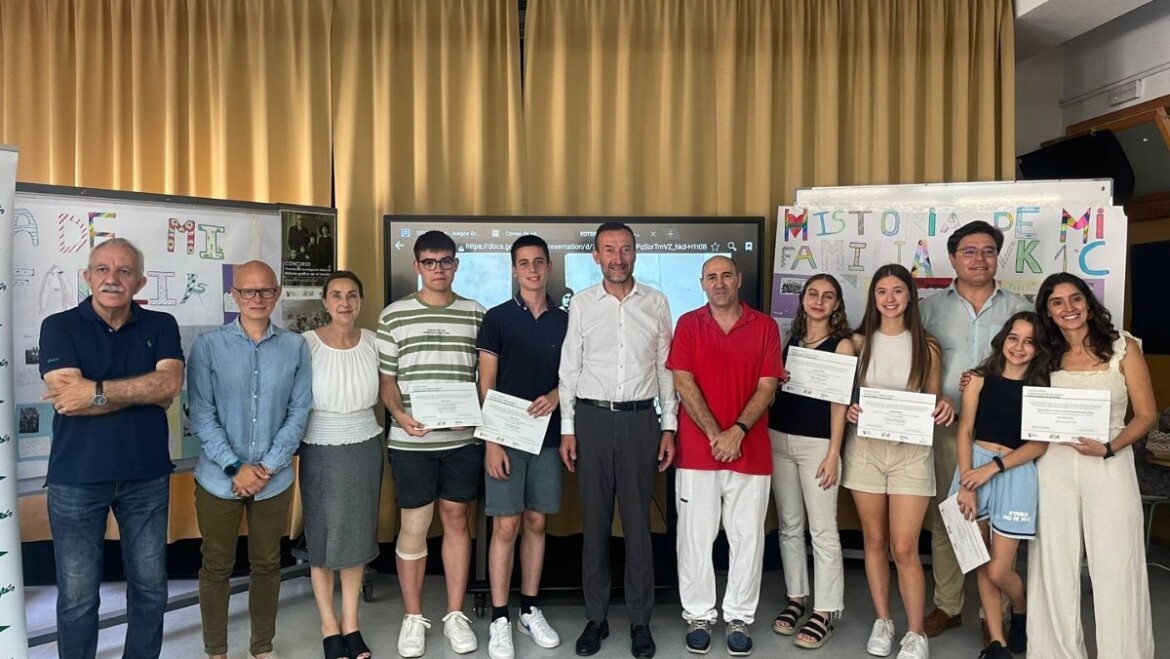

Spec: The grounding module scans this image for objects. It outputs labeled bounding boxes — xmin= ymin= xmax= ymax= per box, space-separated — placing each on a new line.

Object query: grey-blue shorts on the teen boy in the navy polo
xmin=483 ymin=446 xmax=565 ymax=517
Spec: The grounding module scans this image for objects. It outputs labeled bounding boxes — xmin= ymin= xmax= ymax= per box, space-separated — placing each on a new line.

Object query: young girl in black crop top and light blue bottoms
xmin=951 ymin=311 xmax=1051 ymax=659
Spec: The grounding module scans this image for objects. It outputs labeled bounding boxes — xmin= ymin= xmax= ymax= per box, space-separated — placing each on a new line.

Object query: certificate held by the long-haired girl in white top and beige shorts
xmin=858 ymin=386 xmax=935 ymax=446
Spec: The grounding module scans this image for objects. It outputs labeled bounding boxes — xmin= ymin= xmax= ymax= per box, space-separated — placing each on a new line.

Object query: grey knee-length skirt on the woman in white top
xmin=301 ymin=435 xmax=385 ymax=570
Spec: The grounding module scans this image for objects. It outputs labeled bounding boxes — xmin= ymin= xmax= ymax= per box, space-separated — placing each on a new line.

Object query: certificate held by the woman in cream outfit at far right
xmin=1020 ymin=386 xmax=1109 ymax=442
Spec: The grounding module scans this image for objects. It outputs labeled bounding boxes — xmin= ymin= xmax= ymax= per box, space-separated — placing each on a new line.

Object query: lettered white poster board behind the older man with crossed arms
xmin=11 ymin=184 xmax=335 ymax=479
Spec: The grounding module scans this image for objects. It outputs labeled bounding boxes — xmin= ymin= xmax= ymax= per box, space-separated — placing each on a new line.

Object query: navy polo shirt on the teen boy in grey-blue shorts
xmin=475 ymin=295 xmax=569 ymax=448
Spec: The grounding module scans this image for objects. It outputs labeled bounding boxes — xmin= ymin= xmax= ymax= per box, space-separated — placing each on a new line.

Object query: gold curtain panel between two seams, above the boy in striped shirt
xmin=330 ymin=0 xmax=524 ymax=541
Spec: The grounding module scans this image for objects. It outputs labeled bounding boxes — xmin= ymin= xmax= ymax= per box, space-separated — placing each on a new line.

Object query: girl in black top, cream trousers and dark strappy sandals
xmin=769 ymin=274 xmax=853 ymax=648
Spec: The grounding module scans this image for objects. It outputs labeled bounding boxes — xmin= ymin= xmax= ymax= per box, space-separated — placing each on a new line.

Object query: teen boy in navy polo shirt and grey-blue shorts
xmin=475 ymin=235 xmax=569 ymax=659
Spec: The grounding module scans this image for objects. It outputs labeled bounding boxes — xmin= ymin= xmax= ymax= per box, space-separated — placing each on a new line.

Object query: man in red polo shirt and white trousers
xmin=666 ymin=256 xmax=784 ymax=657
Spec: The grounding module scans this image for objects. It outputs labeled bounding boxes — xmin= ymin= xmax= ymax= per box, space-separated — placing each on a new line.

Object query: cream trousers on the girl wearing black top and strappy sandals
xmin=768 ymin=431 xmax=845 ymax=612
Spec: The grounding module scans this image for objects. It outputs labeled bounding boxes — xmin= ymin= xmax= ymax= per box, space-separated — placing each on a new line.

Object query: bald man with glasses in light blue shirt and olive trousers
xmin=187 ymin=261 xmax=312 ymax=659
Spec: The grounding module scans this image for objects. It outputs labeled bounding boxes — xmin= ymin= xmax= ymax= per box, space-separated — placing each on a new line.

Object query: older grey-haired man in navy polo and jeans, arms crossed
xmin=40 ymin=238 xmax=184 ymax=659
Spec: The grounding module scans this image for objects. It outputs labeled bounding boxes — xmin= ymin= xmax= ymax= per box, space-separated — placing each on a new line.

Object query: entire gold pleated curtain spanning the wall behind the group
xmin=0 ymin=0 xmax=1014 ymax=540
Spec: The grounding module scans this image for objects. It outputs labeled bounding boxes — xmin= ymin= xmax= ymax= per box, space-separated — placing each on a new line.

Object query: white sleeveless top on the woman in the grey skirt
xmin=302 ymin=329 xmax=381 ymax=446
